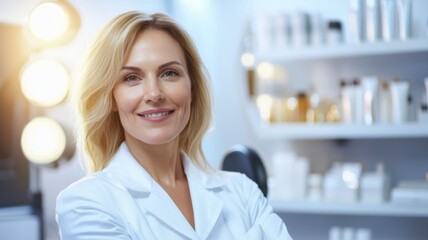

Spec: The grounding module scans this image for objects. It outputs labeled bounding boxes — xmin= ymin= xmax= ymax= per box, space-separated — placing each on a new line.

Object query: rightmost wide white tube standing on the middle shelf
xmin=390 ymin=81 xmax=409 ymax=124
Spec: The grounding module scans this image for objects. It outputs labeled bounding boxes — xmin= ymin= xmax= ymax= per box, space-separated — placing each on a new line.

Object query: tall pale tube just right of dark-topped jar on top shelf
xmin=349 ymin=0 xmax=365 ymax=43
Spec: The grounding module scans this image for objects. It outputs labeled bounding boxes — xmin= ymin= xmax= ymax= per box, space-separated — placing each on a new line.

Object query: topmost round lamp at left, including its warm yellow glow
xmin=26 ymin=0 xmax=80 ymax=48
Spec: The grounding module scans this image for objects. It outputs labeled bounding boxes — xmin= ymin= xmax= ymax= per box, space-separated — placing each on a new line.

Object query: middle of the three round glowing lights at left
xmin=21 ymin=59 xmax=70 ymax=107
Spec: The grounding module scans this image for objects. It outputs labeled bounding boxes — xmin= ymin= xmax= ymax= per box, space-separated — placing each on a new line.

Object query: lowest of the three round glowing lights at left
xmin=21 ymin=117 xmax=66 ymax=164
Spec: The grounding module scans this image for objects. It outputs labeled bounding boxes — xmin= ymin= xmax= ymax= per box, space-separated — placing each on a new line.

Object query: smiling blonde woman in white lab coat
xmin=57 ymin=12 xmax=291 ymax=239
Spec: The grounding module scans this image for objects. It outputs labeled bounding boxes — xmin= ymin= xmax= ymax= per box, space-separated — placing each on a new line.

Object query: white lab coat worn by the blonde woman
xmin=56 ymin=143 xmax=291 ymax=240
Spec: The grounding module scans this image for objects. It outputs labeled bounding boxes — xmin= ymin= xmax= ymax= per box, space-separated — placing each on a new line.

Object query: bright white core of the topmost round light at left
xmin=28 ymin=2 xmax=70 ymax=41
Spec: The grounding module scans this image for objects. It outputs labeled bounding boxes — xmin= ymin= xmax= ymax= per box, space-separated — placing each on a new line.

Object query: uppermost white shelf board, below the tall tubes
xmin=255 ymin=38 xmax=428 ymax=62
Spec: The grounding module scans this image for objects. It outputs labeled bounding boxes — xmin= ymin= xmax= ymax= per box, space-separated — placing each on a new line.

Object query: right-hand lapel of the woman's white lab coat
xmin=183 ymin=154 xmax=224 ymax=239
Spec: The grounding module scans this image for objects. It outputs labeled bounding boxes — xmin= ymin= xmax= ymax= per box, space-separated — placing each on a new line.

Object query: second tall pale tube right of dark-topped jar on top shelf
xmin=365 ymin=0 xmax=380 ymax=42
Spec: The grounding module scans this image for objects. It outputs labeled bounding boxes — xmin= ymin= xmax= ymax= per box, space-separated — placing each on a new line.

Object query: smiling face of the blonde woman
xmin=113 ymin=29 xmax=191 ymax=145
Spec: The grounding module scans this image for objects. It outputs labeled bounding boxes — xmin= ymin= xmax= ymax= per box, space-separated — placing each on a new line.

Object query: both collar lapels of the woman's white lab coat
xmin=106 ymin=143 xmax=226 ymax=239
